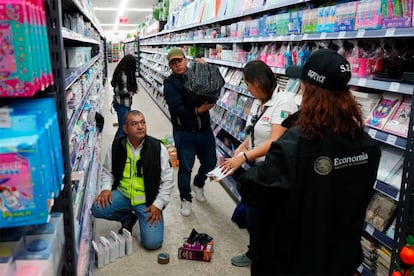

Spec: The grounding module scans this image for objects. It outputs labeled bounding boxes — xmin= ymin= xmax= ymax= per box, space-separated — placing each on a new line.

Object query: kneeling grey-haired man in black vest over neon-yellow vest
xmin=91 ymin=110 xmax=174 ymax=250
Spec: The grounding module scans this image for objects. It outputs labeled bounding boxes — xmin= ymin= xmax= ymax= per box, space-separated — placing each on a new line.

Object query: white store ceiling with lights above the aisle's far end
xmin=91 ymin=0 xmax=157 ymax=37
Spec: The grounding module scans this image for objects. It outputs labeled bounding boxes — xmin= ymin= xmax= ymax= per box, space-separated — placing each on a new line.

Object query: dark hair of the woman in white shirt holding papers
xmin=243 ymin=60 xmax=277 ymax=101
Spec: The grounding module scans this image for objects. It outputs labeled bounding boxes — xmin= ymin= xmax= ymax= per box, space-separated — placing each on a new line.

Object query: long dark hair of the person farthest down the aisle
xmin=111 ymin=55 xmax=138 ymax=91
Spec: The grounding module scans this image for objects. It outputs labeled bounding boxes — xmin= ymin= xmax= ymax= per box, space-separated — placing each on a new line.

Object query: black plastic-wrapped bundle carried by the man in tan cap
xmin=183 ymin=62 xmax=225 ymax=106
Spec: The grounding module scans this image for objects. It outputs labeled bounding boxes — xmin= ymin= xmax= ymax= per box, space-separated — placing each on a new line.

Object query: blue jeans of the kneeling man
xmin=91 ymin=190 xmax=164 ymax=250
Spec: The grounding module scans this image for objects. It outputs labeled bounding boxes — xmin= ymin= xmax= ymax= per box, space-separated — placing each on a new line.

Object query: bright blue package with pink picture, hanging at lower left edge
xmin=0 ymin=135 xmax=49 ymax=227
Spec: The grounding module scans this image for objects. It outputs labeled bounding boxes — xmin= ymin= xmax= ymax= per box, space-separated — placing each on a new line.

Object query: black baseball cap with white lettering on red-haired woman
xmin=286 ymin=49 xmax=351 ymax=91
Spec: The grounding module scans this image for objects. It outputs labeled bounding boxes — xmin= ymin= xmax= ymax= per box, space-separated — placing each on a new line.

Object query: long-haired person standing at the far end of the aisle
xmin=111 ymin=55 xmax=138 ymax=137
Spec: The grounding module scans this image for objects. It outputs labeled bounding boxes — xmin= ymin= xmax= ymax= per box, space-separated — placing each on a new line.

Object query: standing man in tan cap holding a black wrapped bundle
xmin=164 ymin=48 xmax=217 ymax=216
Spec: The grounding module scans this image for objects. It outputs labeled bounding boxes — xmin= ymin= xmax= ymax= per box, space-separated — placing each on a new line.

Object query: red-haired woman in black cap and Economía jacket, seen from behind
xmin=238 ymin=49 xmax=381 ymax=275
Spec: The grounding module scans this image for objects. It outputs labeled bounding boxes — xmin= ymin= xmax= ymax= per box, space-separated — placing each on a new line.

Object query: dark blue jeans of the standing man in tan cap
xmin=173 ymin=128 xmax=217 ymax=202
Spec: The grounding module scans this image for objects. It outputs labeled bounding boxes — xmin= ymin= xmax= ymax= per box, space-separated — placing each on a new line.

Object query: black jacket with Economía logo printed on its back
xmin=238 ymin=126 xmax=381 ymax=275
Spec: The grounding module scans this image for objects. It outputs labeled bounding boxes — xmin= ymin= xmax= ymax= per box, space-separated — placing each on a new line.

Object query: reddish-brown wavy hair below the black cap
xmin=297 ymin=83 xmax=364 ymax=139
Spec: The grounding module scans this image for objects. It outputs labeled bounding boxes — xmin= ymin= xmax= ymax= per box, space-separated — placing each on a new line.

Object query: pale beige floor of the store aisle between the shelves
xmin=94 ymin=63 xmax=250 ymax=276
